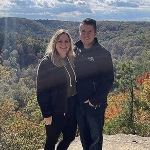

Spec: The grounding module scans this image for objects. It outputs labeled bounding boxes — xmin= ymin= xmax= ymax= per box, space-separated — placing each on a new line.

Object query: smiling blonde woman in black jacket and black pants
xmin=37 ymin=29 xmax=77 ymax=150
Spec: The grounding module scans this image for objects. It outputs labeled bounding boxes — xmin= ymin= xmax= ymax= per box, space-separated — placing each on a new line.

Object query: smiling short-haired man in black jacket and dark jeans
xmin=75 ymin=18 xmax=114 ymax=150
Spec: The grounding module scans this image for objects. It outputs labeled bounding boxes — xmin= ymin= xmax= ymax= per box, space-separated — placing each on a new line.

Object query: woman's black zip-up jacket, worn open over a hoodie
xmin=37 ymin=56 xmax=68 ymax=118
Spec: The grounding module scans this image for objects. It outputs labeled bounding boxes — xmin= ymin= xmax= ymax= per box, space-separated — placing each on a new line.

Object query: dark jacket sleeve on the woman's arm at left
xmin=37 ymin=59 xmax=52 ymax=118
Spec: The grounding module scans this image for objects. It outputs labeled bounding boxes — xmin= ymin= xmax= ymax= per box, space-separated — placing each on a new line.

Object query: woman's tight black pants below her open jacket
xmin=44 ymin=96 xmax=77 ymax=150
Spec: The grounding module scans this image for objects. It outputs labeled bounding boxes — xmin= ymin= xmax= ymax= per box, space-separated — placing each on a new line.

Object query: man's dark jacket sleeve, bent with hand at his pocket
xmin=90 ymin=52 xmax=114 ymax=105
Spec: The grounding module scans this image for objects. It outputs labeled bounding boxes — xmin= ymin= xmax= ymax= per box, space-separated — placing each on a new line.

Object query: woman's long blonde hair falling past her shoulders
xmin=45 ymin=29 xmax=75 ymax=67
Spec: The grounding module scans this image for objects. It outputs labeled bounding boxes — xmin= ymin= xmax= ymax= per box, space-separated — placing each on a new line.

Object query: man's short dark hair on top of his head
xmin=79 ymin=18 xmax=97 ymax=32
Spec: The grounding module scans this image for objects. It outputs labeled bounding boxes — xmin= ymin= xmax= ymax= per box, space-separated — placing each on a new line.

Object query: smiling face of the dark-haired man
xmin=80 ymin=25 xmax=96 ymax=48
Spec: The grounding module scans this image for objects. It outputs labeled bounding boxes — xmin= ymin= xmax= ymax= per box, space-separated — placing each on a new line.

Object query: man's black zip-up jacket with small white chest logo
xmin=74 ymin=38 xmax=114 ymax=106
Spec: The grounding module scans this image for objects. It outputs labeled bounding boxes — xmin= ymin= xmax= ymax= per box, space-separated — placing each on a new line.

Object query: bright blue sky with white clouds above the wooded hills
xmin=0 ymin=0 xmax=150 ymax=22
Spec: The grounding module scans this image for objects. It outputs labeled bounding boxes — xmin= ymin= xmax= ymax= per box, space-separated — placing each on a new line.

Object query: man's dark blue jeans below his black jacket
xmin=76 ymin=104 xmax=107 ymax=150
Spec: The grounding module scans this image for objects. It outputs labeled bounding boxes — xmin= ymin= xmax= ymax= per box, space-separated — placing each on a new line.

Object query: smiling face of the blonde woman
xmin=56 ymin=33 xmax=71 ymax=58
